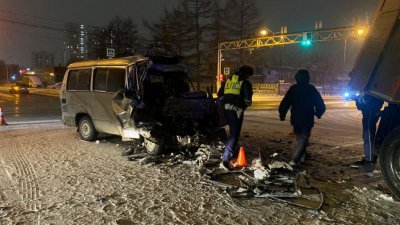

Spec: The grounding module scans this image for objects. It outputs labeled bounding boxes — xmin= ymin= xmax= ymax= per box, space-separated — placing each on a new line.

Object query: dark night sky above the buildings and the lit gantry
xmin=0 ymin=0 xmax=377 ymax=66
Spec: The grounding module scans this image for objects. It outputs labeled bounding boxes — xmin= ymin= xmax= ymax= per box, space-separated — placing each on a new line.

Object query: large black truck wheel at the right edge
xmin=379 ymin=127 xmax=400 ymax=199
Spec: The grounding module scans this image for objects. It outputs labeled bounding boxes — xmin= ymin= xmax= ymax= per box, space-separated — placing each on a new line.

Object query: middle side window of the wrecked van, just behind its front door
xmin=93 ymin=68 xmax=125 ymax=92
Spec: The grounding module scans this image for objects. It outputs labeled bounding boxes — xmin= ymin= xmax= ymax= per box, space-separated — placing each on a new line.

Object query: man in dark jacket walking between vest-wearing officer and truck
xmin=279 ymin=69 xmax=326 ymax=166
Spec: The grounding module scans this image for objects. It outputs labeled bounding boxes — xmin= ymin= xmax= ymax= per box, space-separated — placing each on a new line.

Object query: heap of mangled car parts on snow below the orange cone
xmin=198 ymin=156 xmax=324 ymax=210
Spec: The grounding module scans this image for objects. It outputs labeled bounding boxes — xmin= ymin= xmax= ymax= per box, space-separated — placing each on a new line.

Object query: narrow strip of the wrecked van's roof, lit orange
xmin=68 ymin=56 xmax=148 ymax=68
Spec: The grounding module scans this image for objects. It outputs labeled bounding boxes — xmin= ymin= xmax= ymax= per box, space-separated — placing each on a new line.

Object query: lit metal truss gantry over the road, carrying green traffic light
xmin=217 ymin=26 xmax=369 ymax=90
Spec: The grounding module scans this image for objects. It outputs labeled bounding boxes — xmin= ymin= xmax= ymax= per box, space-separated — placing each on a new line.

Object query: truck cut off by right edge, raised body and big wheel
xmin=349 ymin=0 xmax=400 ymax=199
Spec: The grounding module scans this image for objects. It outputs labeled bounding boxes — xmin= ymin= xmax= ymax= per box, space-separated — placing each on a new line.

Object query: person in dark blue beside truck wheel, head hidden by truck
xmin=356 ymin=95 xmax=383 ymax=164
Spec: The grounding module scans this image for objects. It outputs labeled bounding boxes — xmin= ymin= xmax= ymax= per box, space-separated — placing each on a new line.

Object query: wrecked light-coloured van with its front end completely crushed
xmin=60 ymin=44 xmax=226 ymax=155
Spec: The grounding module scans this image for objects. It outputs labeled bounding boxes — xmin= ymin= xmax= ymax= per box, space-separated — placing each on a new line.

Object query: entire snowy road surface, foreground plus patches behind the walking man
xmin=0 ymin=111 xmax=400 ymax=225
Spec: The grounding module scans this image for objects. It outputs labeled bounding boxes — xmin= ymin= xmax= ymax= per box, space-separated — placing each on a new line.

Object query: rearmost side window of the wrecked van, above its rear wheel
xmin=67 ymin=69 xmax=90 ymax=91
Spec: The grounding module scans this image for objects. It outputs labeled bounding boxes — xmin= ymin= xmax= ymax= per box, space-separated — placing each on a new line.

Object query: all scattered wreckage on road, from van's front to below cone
xmin=122 ymin=142 xmax=324 ymax=210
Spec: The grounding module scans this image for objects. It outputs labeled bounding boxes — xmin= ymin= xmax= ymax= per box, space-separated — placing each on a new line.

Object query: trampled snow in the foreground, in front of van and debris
xmin=0 ymin=123 xmax=399 ymax=224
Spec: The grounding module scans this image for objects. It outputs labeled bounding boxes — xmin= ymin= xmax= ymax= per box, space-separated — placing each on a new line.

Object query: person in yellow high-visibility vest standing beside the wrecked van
xmin=218 ymin=65 xmax=253 ymax=169
